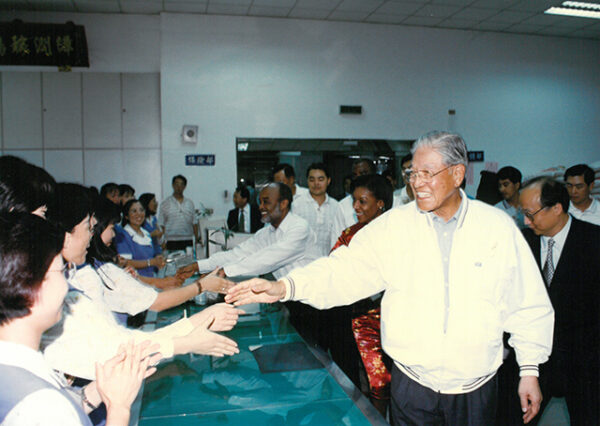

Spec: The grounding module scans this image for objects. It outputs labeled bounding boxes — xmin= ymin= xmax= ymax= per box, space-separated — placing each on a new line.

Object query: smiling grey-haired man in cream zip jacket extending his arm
xmin=225 ymin=132 xmax=554 ymax=425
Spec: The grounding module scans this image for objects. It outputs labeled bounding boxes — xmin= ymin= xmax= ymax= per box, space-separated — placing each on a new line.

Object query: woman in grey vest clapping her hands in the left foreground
xmin=0 ymin=212 xmax=159 ymax=426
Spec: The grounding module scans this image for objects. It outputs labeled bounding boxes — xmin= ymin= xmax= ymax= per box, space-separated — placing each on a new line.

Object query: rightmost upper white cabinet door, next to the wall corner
xmin=121 ymin=74 xmax=160 ymax=148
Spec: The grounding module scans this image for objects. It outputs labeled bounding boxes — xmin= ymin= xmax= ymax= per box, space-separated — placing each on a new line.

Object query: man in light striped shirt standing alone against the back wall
xmin=158 ymin=175 xmax=198 ymax=250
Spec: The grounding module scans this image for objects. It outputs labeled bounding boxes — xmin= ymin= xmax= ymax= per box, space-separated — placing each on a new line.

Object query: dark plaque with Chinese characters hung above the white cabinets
xmin=0 ymin=20 xmax=90 ymax=68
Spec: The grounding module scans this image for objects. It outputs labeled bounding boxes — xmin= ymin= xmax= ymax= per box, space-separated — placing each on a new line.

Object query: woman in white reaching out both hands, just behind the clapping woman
xmin=42 ymin=184 xmax=238 ymax=379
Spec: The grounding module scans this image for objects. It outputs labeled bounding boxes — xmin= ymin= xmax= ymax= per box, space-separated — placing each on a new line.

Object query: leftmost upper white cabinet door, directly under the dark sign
xmin=2 ymin=72 xmax=43 ymax=150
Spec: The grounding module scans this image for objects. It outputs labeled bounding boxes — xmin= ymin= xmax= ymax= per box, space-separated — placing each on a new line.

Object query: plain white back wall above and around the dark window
xmin=0 ymin=14 xmax=600 ymax=214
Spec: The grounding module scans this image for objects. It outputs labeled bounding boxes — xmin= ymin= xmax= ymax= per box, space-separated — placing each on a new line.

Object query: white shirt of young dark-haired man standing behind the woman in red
xmin=292 ymin=193 xmax=345 ymax=256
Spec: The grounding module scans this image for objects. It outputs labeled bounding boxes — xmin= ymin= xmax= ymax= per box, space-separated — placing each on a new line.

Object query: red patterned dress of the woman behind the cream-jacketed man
xmin=331 ymin=223 xmax=392 ymax=399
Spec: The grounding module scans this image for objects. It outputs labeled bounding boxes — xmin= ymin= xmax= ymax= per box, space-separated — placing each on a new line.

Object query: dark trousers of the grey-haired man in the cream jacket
xmin=390 ymin=364 xmax=498 ymax=426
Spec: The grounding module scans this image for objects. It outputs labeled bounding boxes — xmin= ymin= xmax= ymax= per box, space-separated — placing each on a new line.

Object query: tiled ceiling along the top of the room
xmin=0 ymin=0 xmax=600 ymax=40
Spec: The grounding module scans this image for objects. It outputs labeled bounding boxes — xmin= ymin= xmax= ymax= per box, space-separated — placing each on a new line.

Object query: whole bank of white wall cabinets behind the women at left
xmin=0 ymin=72 xmax=161 ymax=198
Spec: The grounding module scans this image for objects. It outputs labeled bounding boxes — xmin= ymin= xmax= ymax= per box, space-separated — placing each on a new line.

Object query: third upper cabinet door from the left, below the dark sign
xmin=82 ymin=73 xmax=123 ymax=148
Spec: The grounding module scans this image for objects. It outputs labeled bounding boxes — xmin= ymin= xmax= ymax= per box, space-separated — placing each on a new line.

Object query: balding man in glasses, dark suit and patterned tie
xmin=520 ymin=177 xmax=600 ymax=425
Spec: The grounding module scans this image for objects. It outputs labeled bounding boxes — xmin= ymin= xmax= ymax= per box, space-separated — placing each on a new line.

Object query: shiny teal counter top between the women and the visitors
xmin=138 ymin=303 xmax=385 ymax=426
